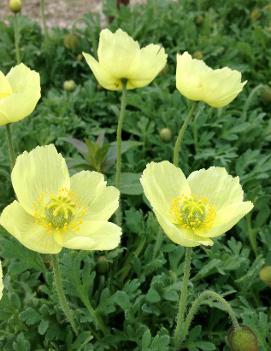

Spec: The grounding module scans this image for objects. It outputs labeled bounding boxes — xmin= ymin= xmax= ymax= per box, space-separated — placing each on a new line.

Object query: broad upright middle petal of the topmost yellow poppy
xmin=98 ymin=29 xmax=140 ymax=79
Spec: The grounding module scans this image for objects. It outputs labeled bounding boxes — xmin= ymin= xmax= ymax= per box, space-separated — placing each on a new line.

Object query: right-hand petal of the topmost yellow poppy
xmin=128 ymin=44 xmax=167 ymax=89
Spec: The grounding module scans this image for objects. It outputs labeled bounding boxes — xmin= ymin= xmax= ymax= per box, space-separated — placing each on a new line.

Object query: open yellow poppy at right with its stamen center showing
xmin=140 ymin=161 xmax=253 ymax=247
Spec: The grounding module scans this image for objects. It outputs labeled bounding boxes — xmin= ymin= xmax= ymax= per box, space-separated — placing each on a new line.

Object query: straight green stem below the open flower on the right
xmin=173 ymin=247 xmax=192 ymax=346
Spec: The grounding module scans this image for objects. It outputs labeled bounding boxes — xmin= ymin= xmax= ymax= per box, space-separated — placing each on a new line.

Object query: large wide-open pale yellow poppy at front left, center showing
xmin=0 ymin=145 xmax=121 ymax=254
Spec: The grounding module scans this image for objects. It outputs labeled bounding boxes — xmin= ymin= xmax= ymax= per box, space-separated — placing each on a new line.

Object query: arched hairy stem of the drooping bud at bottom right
xmin=179 ymin=290 xmax=239 ymax=344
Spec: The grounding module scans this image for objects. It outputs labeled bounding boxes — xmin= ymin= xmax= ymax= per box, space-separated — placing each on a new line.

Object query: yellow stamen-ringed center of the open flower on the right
xmin=170 ymin=195 xmax=216 ymax=230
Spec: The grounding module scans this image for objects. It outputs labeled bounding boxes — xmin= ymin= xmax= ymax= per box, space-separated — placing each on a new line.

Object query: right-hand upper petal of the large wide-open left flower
xmin=71 ymin=171 xmax=120 ymax=221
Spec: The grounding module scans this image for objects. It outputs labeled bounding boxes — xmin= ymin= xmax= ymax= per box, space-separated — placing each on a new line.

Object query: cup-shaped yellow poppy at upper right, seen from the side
xmin=176 ymin=52 xmax=246 ymax=108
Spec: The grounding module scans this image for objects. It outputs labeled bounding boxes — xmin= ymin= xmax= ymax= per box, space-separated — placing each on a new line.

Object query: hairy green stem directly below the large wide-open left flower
xmin=51 ymin=255 xmax=78 ymax=335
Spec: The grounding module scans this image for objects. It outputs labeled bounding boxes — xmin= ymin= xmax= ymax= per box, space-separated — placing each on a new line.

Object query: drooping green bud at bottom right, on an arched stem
xmin=228 ymin=325 xmax=259 ymax=351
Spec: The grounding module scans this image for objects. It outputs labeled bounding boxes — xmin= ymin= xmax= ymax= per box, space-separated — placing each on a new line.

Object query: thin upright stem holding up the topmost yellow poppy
xmin=115 ymin=80 xmax=127 ymax=225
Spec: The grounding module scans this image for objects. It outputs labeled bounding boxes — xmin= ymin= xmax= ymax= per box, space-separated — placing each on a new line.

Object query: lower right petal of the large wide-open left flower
xmin=55 ymin=221 xmax=122 ymax=250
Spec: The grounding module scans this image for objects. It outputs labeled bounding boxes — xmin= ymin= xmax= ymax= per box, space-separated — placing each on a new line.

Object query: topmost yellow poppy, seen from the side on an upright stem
xmin=83 ymin=29 xmax=167 ymax=90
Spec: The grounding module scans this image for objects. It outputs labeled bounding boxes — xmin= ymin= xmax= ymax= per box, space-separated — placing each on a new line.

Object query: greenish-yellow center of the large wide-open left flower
xmin=45 ymin=195 xmax=76 ymax=229
